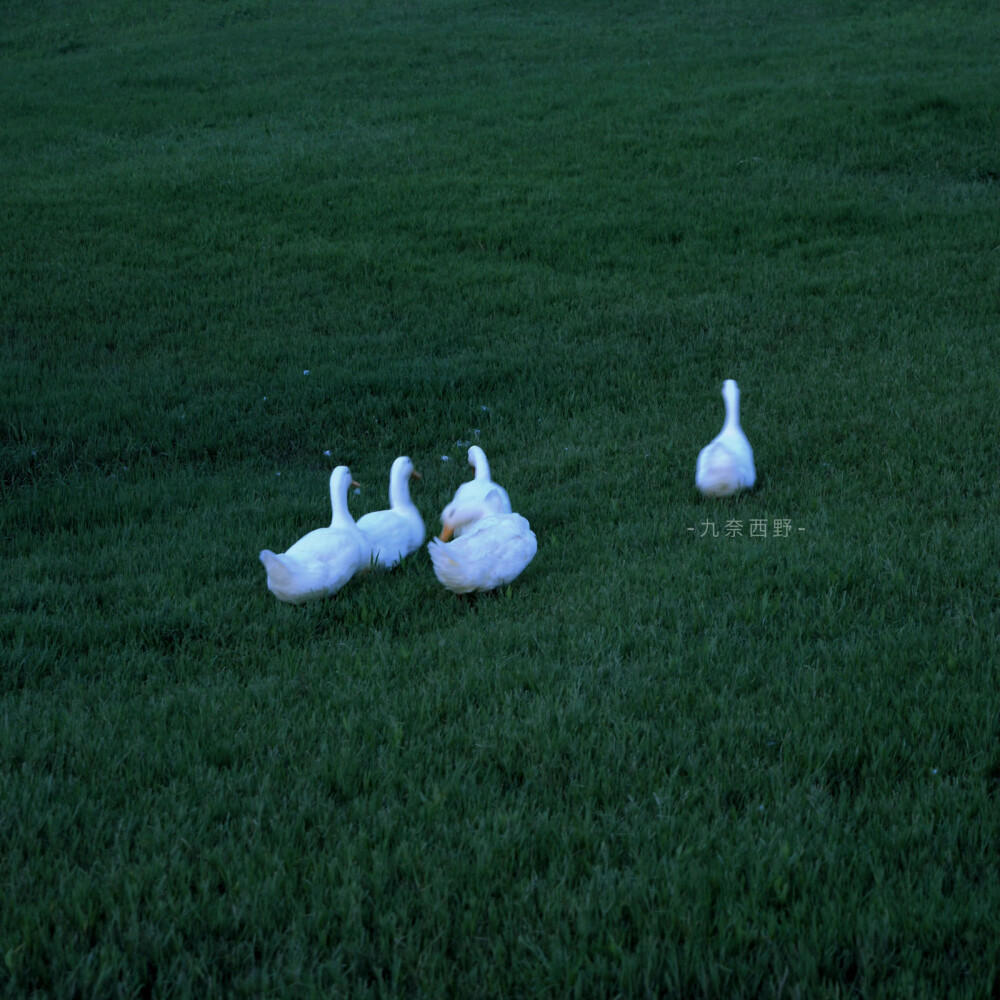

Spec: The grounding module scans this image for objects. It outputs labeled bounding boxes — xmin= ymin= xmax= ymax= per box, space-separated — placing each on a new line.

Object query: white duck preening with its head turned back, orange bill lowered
xmin=427 ymin=488 xmax=538 ymax=594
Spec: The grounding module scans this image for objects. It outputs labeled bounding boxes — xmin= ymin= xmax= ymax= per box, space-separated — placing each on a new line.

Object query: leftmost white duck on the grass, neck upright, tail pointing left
xmin=260 ymin=465 xmax=371 ymax=604
